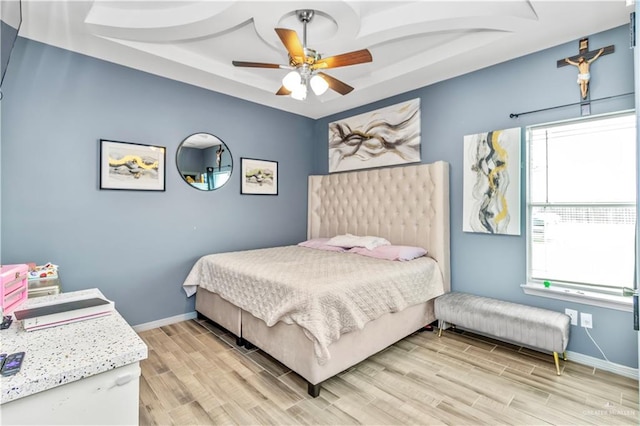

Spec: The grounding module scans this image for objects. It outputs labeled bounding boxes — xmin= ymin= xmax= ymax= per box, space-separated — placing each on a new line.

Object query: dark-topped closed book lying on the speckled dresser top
xmin=13 ymin=297 xmax=114 ymax=331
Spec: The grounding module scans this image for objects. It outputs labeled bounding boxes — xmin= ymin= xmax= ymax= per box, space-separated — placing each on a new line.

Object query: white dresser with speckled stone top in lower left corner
xmin=0 ymin=289 xmax=147 ymax=425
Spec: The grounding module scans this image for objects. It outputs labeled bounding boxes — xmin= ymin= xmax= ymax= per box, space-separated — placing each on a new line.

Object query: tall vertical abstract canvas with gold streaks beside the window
xmin=462 ymin=128 xmax=521 ymax=235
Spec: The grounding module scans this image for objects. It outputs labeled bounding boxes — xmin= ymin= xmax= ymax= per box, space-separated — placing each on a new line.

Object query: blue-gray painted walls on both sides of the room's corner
xmin=0 ymin=26 xmax=638 ymax=368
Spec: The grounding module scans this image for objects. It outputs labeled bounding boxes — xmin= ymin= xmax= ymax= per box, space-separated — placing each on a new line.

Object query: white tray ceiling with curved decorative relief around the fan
xmin=15 ymin=0 xmax=633 ymax=118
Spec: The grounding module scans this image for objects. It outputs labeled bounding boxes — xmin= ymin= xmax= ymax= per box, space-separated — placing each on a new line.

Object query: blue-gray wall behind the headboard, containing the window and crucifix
xmin=313 ymin=26 xmax=638 ymax=368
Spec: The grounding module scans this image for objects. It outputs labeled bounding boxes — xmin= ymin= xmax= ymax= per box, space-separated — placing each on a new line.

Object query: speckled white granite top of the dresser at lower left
xmin=0 ymin=288 xmax=147 ymax=404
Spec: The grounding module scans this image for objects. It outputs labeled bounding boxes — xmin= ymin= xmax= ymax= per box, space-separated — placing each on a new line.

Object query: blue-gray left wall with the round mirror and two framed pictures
xmin=1 ymin=38 xmax=313 ymax=325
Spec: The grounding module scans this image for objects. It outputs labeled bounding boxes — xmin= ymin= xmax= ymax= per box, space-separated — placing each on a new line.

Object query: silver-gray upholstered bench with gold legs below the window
xmin=434 ymin=292 xmax=571 ymax=375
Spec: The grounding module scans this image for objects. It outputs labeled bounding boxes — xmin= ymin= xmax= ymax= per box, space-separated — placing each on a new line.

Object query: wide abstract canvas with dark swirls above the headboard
xmin=329 ymin=99 xmax=420 ymax=173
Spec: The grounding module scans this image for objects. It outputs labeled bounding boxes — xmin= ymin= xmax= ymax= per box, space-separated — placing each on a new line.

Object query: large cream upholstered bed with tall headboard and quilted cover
xmin=183 ymin=161 xmax=450 ymax=397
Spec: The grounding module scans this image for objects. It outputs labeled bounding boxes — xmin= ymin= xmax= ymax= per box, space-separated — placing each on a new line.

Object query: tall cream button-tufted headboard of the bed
xmin=307 ymin=161 xmax=451 ymax=292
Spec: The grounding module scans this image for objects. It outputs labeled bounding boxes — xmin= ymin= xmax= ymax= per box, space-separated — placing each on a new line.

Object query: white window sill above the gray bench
xmin=520 ymin=284 xmax=633 ymax=312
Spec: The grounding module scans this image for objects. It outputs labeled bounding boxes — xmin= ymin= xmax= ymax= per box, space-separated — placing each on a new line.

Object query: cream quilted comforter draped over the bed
xmin=183 ymin=246 xmax=444 ymax=365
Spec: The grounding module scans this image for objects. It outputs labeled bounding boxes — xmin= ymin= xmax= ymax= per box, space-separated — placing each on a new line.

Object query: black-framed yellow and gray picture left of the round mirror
xmin=100 ymin=139 xmax=166 ymax=191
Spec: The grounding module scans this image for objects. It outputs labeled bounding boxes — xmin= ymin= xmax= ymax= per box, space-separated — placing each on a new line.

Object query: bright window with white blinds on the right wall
xmin=525 ymin=113 xmax=636 ymax=308
